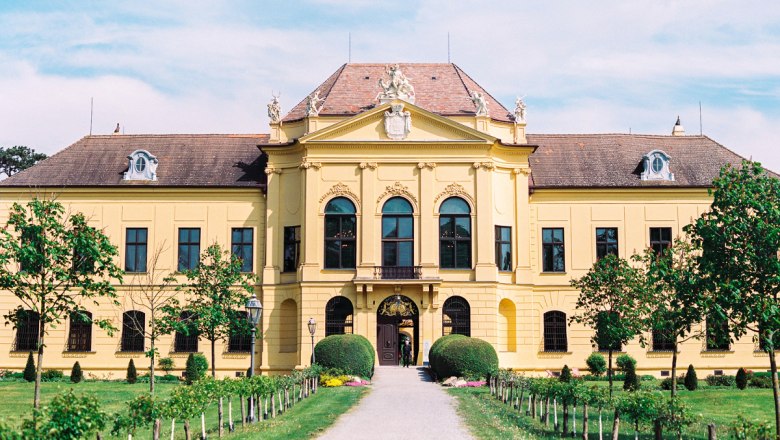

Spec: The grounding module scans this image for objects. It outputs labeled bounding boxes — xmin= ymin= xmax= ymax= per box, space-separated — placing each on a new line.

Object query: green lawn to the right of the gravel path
xmin=449 ymin=387 xmax=774 ymax=440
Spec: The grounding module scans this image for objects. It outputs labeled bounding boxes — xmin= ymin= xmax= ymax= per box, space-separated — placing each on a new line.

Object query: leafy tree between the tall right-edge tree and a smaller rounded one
xmin=633 ymin=237 xmax=711 ymax=398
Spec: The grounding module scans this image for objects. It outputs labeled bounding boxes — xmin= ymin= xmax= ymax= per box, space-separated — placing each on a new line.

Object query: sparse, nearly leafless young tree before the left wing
xmin=123 ymin=242 xmax=176 ymax=395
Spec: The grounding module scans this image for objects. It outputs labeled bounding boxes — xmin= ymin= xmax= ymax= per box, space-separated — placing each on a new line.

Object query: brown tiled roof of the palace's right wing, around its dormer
xmin=527 ymin=134 xmax=743 ymax=188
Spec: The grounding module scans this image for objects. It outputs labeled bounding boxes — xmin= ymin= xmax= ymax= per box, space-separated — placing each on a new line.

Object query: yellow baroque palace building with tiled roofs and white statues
xmin=0 ymin=64 xmax=767 ymax=378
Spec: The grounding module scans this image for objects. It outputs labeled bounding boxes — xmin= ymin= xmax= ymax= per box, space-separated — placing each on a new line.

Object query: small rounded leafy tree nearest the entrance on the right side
xmin=571 ymin=254 xmax=650 ymax=395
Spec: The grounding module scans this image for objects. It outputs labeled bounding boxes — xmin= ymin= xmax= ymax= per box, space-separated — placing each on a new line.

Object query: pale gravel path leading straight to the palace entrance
xmin=320 ymin=367 xmax=473 ymax=440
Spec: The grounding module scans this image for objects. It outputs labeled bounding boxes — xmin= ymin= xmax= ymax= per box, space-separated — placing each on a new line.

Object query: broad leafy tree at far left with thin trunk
xmin=0 ymin=198 xmax=122 ymax=408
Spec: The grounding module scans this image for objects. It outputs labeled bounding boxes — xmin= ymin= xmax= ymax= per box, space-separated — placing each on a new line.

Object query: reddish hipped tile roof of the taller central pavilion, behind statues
xmin=282 ymin=63 xmax=512 ymax=122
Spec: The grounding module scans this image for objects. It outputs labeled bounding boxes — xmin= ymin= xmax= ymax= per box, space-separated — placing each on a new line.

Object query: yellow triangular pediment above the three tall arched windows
xmin=299 ymin=101 xmax=497 ymax=144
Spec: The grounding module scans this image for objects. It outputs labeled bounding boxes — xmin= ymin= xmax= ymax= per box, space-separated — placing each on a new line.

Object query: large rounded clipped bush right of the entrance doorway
xmin=433 ymin=337 xmax=498 ymax=378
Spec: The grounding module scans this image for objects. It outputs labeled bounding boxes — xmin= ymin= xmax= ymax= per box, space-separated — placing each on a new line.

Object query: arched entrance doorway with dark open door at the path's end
xmin=376 ymin=294 xmax=420 ymax=365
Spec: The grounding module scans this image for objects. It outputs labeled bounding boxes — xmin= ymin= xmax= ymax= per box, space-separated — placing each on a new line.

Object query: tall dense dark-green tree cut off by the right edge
xmin=686 ymin=160 xmax=780 ymax=437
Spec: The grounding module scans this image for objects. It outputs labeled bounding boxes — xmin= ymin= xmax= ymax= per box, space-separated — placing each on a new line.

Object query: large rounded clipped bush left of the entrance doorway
xmin=314 ymin=335 xmax=376 ymax=378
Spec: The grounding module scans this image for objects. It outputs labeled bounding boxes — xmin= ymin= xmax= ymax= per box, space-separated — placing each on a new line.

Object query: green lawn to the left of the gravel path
xmin=0 ymin=381 xmax=368 ymax=440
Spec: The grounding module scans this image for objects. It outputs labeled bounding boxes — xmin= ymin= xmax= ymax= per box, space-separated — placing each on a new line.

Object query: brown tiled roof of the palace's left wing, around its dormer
xmin=0 ymin=134 xmax=268 ymax=188
